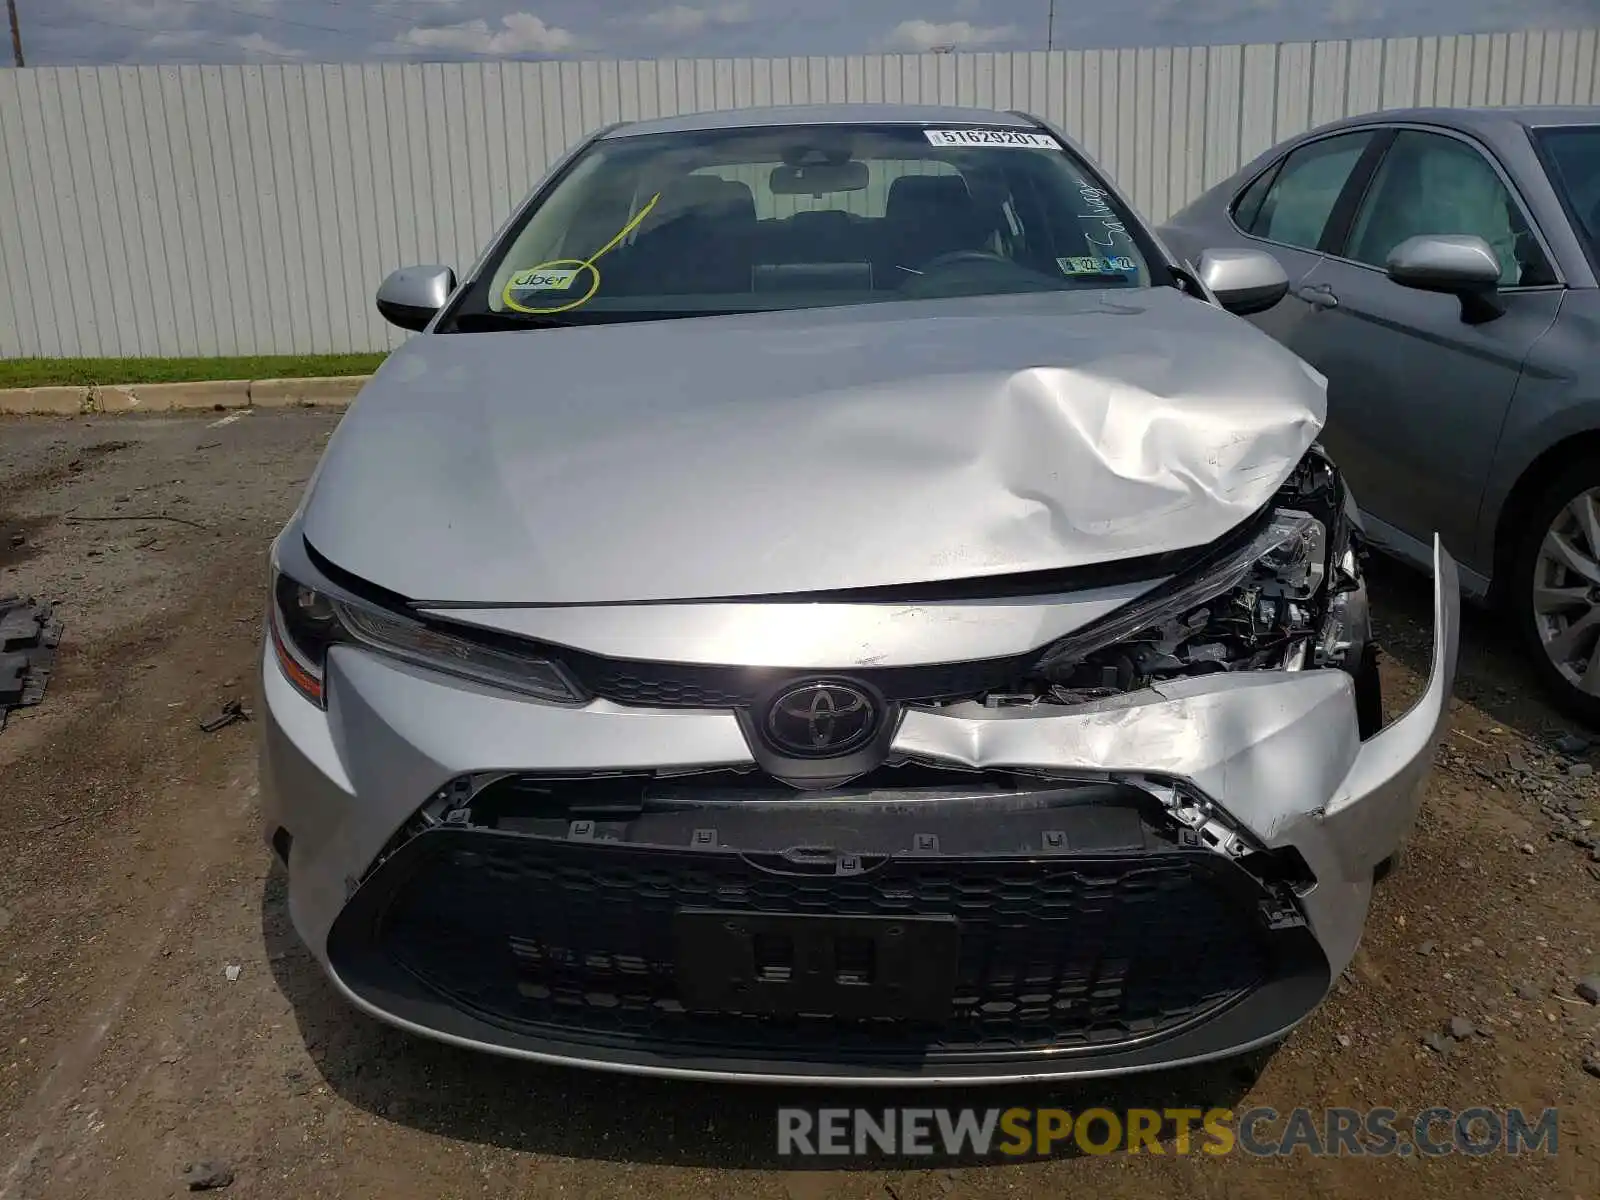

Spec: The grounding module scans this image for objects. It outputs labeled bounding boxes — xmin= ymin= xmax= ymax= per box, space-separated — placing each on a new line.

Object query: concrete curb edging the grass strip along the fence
xmin=0 ymin=374 xmax=371 ymax=416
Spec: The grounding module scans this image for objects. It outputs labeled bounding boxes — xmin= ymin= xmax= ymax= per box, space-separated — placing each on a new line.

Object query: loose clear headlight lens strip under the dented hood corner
xmin=1035 ymin=509 xmax=1328 ymax=674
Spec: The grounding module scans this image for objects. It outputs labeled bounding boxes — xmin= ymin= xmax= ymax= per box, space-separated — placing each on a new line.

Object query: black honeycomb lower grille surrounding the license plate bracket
xmin=330 ymin=827 xmax=1304 ymax=1061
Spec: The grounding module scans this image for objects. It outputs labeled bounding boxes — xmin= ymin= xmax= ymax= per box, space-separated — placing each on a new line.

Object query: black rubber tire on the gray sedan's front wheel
xmin=1506 ymin=461 xmax=1600 ymax=728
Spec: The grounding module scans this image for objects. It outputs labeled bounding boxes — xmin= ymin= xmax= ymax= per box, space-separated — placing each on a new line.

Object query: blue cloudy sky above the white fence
xmin=12 ymin=0 xmax=1600 ymax=66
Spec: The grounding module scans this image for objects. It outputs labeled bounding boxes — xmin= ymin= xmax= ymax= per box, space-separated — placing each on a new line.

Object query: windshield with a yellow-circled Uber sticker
xmin=446 ymin=125 xmax=1150 ymax=330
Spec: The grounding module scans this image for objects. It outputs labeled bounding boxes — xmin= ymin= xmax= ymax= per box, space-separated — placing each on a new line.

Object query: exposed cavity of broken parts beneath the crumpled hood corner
xmin=984 ymin=446 xmax=1382 ymax=736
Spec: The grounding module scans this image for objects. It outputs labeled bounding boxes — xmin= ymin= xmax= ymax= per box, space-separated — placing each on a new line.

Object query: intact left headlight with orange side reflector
xmin=270 ymin=574 xmax=584 ymax=707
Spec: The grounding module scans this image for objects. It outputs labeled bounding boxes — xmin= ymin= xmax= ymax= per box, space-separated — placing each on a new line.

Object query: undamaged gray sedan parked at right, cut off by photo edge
xmin=1162 ymin=107 xmax=1600 ymax=723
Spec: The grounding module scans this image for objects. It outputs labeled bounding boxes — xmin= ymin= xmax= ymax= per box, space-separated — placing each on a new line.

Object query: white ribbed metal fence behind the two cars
xmin=0 ymin=29 xmax=1600 ymax=357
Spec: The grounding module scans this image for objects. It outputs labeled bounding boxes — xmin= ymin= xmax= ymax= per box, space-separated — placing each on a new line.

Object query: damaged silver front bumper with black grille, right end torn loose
xmin=262 ymin=546 xmax=1459 ymax=1083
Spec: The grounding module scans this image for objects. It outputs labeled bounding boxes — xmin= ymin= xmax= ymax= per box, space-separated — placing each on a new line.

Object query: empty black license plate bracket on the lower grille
xmin=674 ymin=909 xmax=960 ymax=1021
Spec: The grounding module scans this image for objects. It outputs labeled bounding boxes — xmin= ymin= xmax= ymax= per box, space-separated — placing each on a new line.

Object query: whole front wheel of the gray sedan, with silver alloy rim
xmin=1517 ymin=464 xmax=1600 ymax=723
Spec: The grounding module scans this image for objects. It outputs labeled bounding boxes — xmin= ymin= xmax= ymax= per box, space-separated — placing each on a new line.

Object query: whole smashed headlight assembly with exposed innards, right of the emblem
xmin=1035 ymin=509 xmax=1328 ymax=691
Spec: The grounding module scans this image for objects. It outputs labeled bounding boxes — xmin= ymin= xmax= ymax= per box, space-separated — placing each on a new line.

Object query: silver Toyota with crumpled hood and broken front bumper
xmin=262 ymin=107 xmax=1458 ymax=1083
